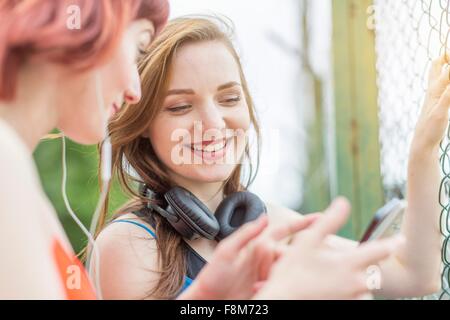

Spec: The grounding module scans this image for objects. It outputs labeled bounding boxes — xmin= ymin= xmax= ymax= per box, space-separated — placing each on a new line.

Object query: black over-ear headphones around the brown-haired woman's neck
xmin=140 ymin=185 xmax=267 ymax=241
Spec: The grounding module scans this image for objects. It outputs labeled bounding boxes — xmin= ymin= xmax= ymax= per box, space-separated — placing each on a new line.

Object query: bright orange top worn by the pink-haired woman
xmin=53 ymin=239 xmax=96 ymax=300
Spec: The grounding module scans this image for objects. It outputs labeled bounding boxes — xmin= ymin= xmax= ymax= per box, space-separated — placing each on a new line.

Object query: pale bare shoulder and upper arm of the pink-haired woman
xmin=0 ymin=123 xmax=63 ymax=299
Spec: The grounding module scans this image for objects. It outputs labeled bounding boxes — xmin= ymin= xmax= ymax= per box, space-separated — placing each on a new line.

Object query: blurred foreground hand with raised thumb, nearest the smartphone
xmin=254 ymin=199 xmax=403 ymax=299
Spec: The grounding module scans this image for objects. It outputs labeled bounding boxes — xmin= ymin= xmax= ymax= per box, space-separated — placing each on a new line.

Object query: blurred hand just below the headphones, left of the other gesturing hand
xmin=178 ymin=215 xmax=318 ymax=300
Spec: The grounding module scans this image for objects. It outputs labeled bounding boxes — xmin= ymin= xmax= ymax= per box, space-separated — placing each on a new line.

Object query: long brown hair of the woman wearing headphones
xmin=97 ymin=17 xmax=260 ymax=299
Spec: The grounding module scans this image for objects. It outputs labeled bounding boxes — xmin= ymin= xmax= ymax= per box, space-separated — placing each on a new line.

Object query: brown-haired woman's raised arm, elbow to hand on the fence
xmin=377 ymin=56 xmax=450 ymax=298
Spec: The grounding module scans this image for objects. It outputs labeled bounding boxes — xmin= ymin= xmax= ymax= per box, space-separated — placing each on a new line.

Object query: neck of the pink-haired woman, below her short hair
xmin=0 ymin=66 xmax=57 ymax=153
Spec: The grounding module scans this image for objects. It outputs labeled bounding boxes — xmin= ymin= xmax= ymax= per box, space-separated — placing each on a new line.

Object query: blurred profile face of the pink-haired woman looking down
xmin=57 ymin=19 xmax=155 ymax=144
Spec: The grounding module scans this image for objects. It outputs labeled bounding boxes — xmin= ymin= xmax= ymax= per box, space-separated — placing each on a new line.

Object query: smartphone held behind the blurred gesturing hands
xmin=360 ymin=199 xmax=406 ymax=243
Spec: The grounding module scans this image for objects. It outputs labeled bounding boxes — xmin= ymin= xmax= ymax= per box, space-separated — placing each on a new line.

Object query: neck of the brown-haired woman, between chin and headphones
xmin=170 ymin=177 xmax=224 ymax=212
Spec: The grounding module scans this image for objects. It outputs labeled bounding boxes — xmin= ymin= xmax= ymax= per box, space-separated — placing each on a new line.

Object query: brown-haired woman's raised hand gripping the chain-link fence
xmin=411 ymin=56 xmax=450 ymax=154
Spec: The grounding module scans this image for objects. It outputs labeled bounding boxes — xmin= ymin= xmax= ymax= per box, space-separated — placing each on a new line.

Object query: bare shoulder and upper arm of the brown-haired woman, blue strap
xmin=97 ymin=214 xmax=160 ymax=299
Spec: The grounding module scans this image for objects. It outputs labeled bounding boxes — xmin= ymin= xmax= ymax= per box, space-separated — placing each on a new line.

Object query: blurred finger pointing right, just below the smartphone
xmin=349 ymin=236 xmax=405 ymax=268
